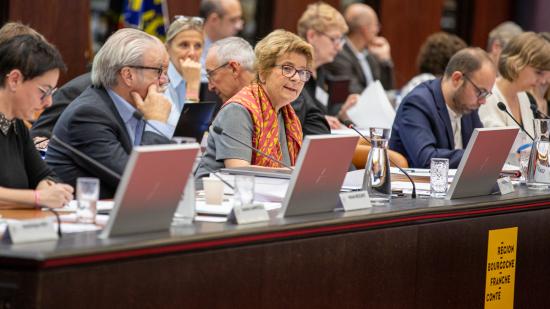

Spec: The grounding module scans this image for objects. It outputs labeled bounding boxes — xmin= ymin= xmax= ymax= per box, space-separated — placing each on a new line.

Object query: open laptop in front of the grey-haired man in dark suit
xmin=99 ymin=143 xmax=199 ymax=238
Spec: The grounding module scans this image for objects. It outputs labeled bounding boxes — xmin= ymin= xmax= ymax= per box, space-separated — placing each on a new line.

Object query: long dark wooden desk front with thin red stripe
xmin=0 ymin=186 xmax=550 ymax=308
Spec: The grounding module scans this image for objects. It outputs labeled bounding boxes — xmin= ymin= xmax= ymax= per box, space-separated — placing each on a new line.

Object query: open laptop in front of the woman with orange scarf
xmin=281 ymin=135 xmax=359 ymax=217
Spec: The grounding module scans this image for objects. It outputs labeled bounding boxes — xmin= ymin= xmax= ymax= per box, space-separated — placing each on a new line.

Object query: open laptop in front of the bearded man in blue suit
xmin=446 ymin=127 xmax=519 ymax=199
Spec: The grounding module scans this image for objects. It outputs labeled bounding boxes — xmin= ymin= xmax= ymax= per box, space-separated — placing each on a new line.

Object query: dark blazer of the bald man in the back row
xmin=323 ymin=42 xmax=395 ymax=93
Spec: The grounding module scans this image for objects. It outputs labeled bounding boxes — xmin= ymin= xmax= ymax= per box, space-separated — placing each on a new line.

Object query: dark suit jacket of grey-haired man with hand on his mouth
xmin=46 ymin=87 xmax=170 ymax=198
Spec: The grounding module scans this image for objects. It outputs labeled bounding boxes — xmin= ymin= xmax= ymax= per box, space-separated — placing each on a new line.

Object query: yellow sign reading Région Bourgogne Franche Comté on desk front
xmin=485 ymin=227 xmax=518 ymax=309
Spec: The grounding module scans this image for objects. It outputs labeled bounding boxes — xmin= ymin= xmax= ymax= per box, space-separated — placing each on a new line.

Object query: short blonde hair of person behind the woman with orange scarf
xmin=298 ymin=1 xmax=348 ymax=38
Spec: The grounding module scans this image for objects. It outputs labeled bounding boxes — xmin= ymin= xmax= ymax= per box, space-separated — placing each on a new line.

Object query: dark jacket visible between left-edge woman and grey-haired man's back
xmin=31 ymin=73 xmax=92 ymax=138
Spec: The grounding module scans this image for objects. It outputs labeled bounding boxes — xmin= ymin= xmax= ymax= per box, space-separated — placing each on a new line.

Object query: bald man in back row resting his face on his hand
xmin=327 ymin=3 xmax=395 ymax=93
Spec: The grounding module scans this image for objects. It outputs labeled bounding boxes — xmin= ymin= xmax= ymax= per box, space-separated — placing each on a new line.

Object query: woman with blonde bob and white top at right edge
xmin=479 ymin=32 xmax=550 ymax=136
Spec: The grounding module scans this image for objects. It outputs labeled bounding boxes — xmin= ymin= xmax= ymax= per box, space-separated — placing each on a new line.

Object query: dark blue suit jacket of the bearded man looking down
xmin=389 ymin=79 xmax=483 ymax=168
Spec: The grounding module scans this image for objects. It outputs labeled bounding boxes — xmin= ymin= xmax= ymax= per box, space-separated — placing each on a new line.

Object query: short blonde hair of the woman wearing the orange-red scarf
xmin=254 ymin=29 xmax=313 ymax=81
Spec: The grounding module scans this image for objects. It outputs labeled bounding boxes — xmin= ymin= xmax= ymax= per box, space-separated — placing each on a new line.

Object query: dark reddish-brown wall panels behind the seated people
xmin=0 ymin=0 xmax=550 ymax=86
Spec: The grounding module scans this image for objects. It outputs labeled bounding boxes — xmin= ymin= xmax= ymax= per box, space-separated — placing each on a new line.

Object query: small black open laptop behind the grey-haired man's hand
xmin=174 ymin=102 xmax=216 ymax=143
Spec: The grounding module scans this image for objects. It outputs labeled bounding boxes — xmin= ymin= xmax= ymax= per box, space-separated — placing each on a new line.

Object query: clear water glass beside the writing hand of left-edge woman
xmin=76 ymin=177 xmax=99 ymax=223
